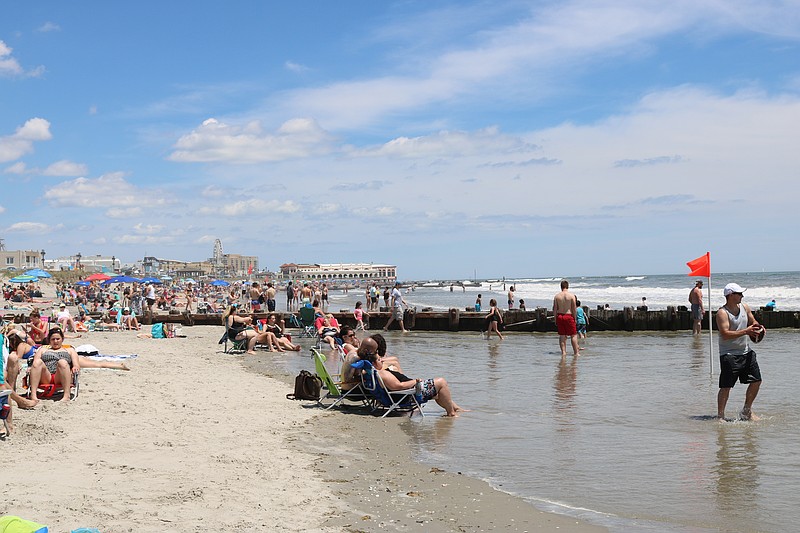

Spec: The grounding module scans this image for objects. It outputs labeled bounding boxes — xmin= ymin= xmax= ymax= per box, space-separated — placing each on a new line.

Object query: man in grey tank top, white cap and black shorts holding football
xmin=717 ymin=283 xmax=763 ymax=420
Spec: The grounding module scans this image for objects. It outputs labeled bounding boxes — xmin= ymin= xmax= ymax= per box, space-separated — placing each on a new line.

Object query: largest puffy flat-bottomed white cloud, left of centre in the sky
xmin=169 ymin=118 xmax=334 ymax=163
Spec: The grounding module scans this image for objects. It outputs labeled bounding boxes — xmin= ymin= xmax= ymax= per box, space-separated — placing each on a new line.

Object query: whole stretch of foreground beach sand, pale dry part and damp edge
xmin=0 ymin=318 xmax=602 ymax=533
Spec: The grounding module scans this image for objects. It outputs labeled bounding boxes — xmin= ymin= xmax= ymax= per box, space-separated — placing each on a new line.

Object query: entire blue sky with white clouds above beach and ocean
xmin=0 ymin=0 xmax=800 ymax=279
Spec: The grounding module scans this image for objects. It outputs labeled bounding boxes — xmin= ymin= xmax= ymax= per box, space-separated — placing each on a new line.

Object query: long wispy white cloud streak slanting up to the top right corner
xmin=262 ymin=0 xmax=800 ymax=131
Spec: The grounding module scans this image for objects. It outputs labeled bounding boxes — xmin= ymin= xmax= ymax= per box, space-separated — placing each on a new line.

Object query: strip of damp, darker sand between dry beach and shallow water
xmin=243 ymin=342 xmax=607 ymax=533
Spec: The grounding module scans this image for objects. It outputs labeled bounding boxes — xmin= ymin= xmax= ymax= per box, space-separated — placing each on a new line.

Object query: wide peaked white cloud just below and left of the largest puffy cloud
xmin=44 ymin=172 xmax=165 ymax=208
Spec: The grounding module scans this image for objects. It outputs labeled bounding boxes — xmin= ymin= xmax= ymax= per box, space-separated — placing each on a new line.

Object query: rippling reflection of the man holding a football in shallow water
xmin=712 ymin=422 xmax=760 ymax=518
